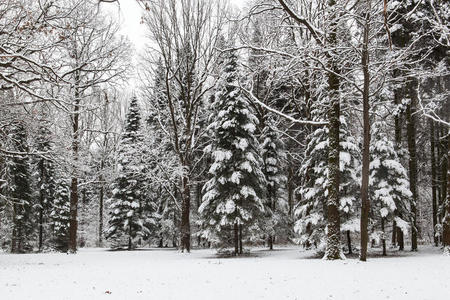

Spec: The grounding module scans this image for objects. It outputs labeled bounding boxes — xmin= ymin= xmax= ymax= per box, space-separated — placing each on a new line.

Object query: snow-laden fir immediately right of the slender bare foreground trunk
xmin=369 ymin=121 xmax=412 ymax=255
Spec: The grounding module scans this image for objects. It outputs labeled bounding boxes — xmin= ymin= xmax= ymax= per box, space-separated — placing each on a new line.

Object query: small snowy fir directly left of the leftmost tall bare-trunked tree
xmin=49 ymin=177 xmax=70 ymax=252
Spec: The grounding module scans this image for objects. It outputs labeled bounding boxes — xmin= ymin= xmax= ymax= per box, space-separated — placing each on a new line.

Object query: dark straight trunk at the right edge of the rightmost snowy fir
xmin=406 ymin=78 xmax=419 ymax=251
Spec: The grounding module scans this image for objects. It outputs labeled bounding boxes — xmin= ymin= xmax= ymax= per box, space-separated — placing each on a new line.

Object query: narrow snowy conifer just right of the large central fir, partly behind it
xmin=261 ymin=120 xmax=288 ymax=250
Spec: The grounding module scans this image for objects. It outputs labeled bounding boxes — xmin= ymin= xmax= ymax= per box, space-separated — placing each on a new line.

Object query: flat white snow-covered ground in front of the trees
xmin=0 ymin=247 xmax=450 ymax=300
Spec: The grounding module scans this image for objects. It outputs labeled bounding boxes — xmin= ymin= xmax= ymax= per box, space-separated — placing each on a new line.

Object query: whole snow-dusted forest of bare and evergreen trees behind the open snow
xmin=0 ymin=0 xmax=450 ymax=260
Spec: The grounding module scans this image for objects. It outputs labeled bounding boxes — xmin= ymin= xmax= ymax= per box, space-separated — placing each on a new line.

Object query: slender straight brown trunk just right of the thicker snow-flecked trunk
xmin=359 ymin=13 xmax=370 ymax=261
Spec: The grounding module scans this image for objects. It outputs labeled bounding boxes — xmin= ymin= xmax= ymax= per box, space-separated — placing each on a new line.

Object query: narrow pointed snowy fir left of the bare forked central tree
xmin=106 ymin=97 xmax=149 ymax=250
